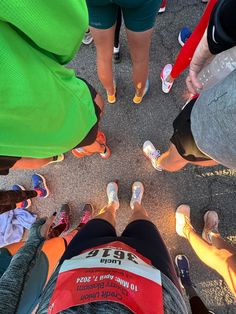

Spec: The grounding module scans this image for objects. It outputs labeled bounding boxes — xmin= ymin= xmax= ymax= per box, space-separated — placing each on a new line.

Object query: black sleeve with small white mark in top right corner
xmin=207 ymin=0 xmax=236 ymax=54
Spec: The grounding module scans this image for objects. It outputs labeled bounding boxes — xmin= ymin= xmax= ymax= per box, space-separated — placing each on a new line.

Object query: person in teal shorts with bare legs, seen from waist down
xmin=87 ymin=0 xmax=161 ymax=104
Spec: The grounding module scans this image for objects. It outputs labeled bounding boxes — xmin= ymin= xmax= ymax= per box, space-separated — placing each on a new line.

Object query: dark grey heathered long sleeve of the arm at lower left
xmin=0 ymin=219 xmax=45 ymax=314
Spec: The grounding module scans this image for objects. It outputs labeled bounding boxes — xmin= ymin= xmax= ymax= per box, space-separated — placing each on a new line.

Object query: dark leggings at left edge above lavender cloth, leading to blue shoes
xmin=0 ymin=190 xmax=38 ymax=214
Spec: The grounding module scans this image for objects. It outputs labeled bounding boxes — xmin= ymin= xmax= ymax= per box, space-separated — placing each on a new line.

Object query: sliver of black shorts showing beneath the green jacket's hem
xmin=75 ymin=77 xmax=101 ymax=148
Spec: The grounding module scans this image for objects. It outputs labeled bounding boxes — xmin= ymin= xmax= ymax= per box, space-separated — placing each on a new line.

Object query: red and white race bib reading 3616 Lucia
xmin=48 ymin=241 xmax=164 ymax=314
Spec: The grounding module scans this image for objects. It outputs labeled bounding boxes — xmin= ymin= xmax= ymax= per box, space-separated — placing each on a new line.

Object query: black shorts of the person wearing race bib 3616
xmin=60 ymin=218 xmax=181 ymax=291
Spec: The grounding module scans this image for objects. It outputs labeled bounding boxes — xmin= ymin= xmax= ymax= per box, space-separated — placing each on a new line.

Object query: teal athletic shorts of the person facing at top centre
xmin=87 ymin=0 xmax=161 ymax=32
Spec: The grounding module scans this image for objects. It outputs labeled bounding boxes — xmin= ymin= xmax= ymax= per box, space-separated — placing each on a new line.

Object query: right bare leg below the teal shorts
xmin=127 ymin=28 xmax=153 ymax=96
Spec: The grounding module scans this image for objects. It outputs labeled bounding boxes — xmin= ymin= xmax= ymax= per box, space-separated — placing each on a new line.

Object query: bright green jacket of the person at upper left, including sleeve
xmin=0 ymin=0 xmax=97 ymax=158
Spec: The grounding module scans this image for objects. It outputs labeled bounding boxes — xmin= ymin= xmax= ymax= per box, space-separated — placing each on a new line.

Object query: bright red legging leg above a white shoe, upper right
xmin=170 ymin=0 xmax=218 ymax=79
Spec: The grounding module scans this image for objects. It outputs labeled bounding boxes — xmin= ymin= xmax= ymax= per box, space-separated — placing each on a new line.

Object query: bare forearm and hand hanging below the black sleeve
xmin=186 ymin=30 xmax=213 ymax=95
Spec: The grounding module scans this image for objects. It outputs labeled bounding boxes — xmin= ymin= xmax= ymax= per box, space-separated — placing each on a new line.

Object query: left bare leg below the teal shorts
xmin=90 ymin=25 xmax=115 ymax=95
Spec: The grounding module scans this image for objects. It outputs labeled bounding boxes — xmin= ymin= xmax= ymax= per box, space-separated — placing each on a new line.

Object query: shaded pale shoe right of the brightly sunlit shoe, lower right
xmin=202 ymin=210 xmax=219 ymax=244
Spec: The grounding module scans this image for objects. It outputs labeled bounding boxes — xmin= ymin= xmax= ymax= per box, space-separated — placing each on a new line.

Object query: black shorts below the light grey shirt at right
xmin=170 ymin=98 xmax=211 ymax=161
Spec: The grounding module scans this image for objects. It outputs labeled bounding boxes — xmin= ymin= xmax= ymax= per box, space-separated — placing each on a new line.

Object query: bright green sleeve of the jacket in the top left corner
xmin=0 ymin=0 xmax=88 ymax=64
